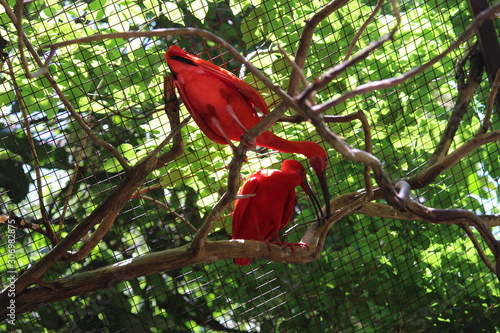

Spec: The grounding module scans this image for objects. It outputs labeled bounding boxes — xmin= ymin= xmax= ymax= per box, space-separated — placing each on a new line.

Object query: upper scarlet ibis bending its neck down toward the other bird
xmin=165 ymin=45 xmax=330 ymax=217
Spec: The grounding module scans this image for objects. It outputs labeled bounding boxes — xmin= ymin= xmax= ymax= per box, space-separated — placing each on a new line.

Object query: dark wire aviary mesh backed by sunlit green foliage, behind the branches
xmin=0 ymin=0 xmax=500 ymax=332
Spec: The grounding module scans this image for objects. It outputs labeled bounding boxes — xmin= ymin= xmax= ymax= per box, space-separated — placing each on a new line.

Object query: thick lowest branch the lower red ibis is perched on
xmin=0 ymin=236 xmax=322 ymax=320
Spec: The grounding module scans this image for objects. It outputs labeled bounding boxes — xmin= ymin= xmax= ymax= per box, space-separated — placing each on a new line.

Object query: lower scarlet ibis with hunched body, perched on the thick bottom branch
xmin=233 ymin=160 xmax=316 ymax=266
